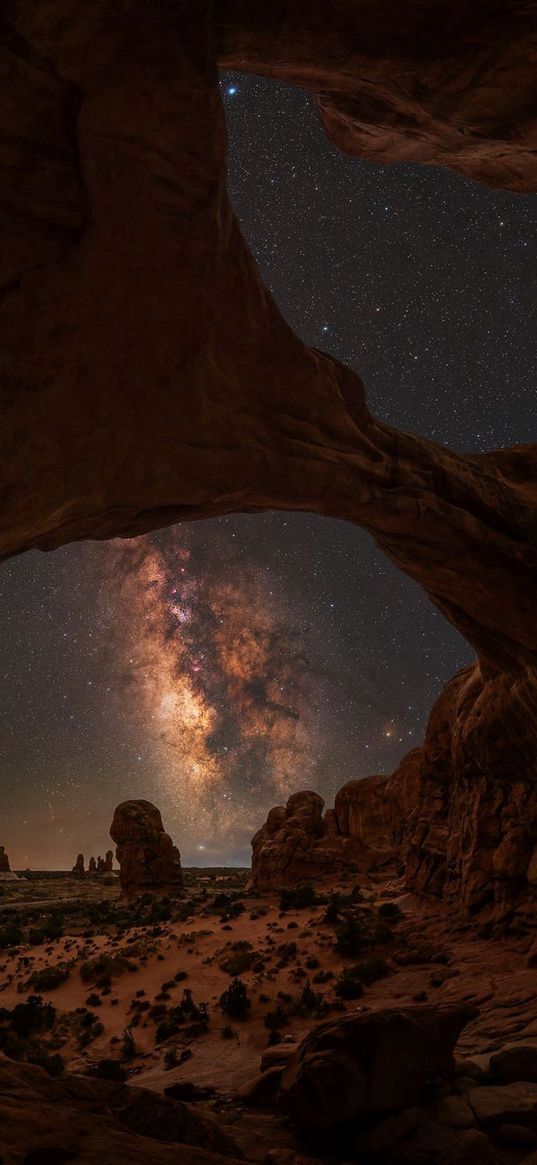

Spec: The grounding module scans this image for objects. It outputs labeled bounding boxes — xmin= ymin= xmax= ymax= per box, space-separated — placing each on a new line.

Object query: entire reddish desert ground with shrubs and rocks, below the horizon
xmin=0 ymin=870 xmax=537 ymax=1165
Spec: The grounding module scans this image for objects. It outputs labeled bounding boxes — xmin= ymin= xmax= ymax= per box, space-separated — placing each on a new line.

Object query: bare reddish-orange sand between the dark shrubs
xmin=0 ymin=884 xmax=537 ymax=1096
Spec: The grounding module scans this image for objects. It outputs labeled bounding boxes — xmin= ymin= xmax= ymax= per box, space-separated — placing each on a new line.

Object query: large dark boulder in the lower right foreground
xmin=278 ymin=1004 xmax=476 ymax=1136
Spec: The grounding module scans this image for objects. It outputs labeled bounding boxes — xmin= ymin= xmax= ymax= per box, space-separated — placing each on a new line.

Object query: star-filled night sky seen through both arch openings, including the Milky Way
xmin=0 ymin=73 xmax=537 ymax=869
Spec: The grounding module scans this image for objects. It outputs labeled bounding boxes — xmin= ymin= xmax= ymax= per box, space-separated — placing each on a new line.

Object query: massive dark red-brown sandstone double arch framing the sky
xmin=0 ymin=0 xmax=537 ymax=910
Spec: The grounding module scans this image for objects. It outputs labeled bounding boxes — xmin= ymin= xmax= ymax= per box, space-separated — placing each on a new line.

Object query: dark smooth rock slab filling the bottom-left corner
xmin=0 ymin=1053 xmax=242 ymax=1165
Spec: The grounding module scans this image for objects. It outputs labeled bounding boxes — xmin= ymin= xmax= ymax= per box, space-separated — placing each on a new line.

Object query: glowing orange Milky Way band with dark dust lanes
xmin=98 ymin=528 xmax=330 ymax=850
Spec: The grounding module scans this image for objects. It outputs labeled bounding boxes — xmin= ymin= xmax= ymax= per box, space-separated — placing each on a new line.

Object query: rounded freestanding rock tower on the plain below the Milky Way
xmin=109 ymin=800 xmax=183 ymax=898
